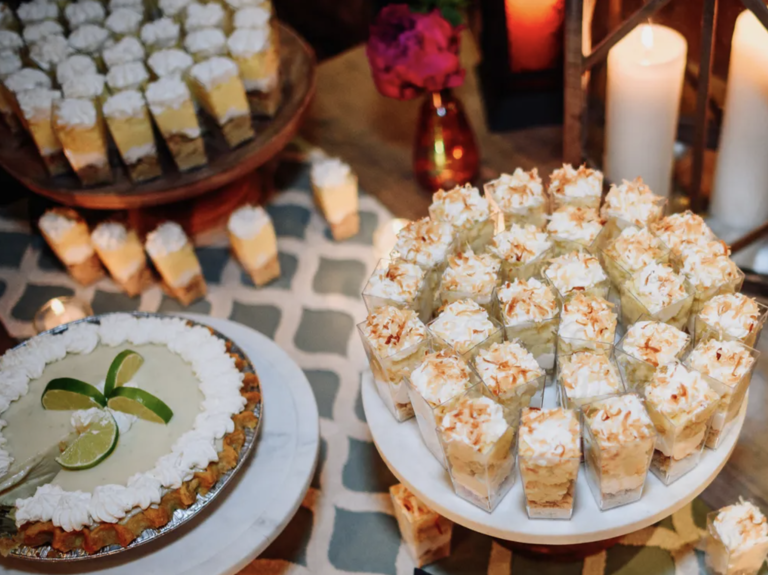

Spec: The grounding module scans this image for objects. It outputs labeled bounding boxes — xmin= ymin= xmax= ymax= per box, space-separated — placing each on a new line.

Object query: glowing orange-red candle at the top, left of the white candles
xmin=505 ymin=0 xmax=565 ymax=72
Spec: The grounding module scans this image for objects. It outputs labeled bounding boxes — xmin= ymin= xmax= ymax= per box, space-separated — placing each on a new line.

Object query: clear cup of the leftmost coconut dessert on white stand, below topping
xmin=357 ymin=322 xmax=430 ymax=422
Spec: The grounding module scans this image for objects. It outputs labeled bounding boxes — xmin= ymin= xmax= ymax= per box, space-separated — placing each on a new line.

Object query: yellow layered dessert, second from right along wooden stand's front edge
xmin=189 ymin=57 xmax=255 ymax=148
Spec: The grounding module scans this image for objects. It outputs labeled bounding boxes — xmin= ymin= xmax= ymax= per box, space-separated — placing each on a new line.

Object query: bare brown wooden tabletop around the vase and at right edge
xmin=302 ymin=35 xmax=768 ymax=524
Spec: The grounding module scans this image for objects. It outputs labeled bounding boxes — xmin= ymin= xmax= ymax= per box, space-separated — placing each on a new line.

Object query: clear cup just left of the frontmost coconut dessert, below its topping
xmin=438 ymin=384 xmax=516 ymax=513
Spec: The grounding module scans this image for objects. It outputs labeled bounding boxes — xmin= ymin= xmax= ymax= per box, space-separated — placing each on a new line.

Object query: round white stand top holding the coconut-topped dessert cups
xmin=362 ymin=371 xmax=746 ymax=545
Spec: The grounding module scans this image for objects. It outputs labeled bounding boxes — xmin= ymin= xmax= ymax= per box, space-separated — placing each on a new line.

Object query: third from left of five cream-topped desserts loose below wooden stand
xmin=145 ymin=222 xmax=207 ymax=305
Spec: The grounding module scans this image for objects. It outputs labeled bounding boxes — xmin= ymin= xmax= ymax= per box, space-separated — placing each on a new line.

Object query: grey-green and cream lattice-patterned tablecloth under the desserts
xmin=0 ymin=160 xmax=728 ymax=575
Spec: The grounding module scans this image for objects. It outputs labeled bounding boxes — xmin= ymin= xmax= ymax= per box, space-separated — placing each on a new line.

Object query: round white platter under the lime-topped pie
xmin=0 ymin=314 xmax=320 ymax=575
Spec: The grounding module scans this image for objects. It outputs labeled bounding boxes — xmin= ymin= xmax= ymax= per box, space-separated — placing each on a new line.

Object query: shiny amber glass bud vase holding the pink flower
xmin=413 ymin=89 xmax=480 ymax=192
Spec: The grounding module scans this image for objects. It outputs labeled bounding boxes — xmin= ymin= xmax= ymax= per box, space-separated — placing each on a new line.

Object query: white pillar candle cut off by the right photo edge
xmin=711 ymin=10 xmax=768 ymax=228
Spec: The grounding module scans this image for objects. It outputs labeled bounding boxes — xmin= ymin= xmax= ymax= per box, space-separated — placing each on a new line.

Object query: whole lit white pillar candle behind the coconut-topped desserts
xmin=603 ymin=24 xmax=688 ymax=196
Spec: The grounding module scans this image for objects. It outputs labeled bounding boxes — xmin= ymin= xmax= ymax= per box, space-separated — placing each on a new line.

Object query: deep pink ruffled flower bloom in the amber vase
xmin=367 ymin=4 xmax=465 ymax=100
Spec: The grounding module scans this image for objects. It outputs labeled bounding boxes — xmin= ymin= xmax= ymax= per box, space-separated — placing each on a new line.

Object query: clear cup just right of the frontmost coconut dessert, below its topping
xmin=581 ymin=394 xmax=656 ymax=511
